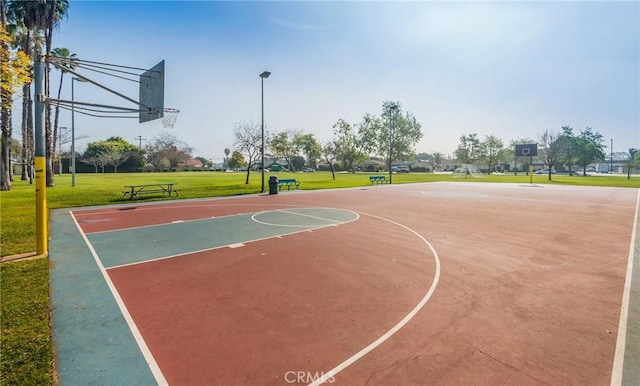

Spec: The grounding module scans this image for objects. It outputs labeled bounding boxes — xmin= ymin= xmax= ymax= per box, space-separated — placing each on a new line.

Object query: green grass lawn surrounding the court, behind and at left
xmin=0 ymin=172 xmax=640 ymax=385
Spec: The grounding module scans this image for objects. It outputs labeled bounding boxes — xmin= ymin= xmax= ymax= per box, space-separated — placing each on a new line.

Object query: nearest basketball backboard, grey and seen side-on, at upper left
xmin=139 ymin=60 xmax=164 ymax=123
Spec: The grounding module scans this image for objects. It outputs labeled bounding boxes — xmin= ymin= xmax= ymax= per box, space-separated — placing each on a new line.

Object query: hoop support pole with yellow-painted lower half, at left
xmin=33 ymin=51 xmax=49 ymax=255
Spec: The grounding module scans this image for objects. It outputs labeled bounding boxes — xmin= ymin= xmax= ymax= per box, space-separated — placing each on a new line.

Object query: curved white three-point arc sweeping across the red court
xmin=309 ymin=213 xmax=440 ymax=386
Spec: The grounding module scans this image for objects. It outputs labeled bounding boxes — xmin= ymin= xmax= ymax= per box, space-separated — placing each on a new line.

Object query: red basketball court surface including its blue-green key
xmin=52 ymin=183 xmax=639 ymax=385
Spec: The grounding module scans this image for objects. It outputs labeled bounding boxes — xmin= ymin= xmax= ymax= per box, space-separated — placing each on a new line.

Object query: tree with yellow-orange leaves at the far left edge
xmin=0 ymin=18 xmax=30 ymax=190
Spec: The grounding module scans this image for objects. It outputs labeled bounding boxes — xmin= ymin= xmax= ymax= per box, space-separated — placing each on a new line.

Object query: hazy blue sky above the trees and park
xmin=33 ymin=0 xmax=640 ymax=162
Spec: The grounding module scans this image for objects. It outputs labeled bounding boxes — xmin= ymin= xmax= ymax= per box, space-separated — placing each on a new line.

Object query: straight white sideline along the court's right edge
xmin=611 ymin=190 xmax=640 ymax=386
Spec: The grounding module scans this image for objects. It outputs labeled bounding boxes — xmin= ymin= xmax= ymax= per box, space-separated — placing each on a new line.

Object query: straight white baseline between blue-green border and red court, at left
xmin=69 ymin=212 xmax=169 ymax=386
